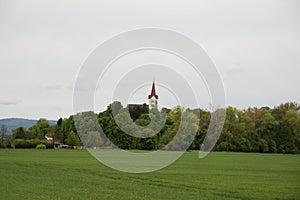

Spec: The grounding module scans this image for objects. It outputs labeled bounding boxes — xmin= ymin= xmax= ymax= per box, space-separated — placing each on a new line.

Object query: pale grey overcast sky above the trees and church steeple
xmin=0 ymin=0 xmax=300 ymax=119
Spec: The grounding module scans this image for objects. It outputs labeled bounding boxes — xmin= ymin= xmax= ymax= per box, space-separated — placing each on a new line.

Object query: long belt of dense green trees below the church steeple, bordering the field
xmin=1 ymin=102 xmax=300 ymax=153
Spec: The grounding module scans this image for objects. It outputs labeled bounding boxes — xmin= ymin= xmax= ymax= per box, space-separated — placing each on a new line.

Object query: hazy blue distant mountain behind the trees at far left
xmin=0 ymin=118 xmax=56 ymax=135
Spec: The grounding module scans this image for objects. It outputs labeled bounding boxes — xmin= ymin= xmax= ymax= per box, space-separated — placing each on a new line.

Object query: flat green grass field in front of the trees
xmin=0 ymin=149 xmax=300 ymax=199
